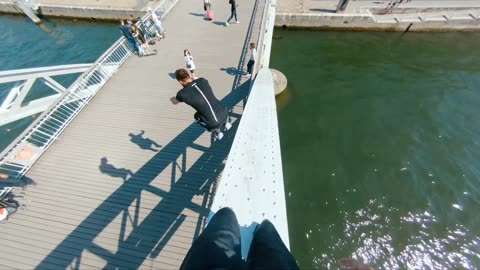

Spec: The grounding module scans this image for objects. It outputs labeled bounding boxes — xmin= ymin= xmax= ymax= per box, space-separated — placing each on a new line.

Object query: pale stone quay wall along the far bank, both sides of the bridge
xmin=0 ymin=0 xmax=480 ymax=31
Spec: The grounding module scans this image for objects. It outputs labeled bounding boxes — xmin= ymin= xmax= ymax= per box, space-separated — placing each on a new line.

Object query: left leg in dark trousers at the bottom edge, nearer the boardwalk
xmin=180 ymin=208 xmax=245 ymax=270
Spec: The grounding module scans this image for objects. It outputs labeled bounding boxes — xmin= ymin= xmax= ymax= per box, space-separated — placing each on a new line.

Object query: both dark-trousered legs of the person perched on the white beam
xmin=180 ymin=208 xmax=299 ymax=270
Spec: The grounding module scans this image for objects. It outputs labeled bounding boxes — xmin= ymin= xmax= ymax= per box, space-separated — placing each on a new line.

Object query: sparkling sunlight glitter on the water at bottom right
xmin=334 ymin=200 xmax=480 ymax=269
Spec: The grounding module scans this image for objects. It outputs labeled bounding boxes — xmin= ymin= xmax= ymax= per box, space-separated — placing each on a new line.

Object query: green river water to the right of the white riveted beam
xmin=270 ymin=30 xmax=480 ymax=269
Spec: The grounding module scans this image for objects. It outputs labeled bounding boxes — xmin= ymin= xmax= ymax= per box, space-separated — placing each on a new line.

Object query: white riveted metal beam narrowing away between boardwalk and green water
xmin=207 ymin=0 xmax=290 ymax=258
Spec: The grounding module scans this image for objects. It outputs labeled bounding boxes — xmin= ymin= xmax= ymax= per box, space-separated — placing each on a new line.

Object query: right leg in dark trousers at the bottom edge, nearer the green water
xmin=247 ymin=220 xmax=300 ymax=270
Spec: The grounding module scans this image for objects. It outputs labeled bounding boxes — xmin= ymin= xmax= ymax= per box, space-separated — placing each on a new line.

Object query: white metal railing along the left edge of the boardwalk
xmin=0 ymin=0 xmax=178 ymax=178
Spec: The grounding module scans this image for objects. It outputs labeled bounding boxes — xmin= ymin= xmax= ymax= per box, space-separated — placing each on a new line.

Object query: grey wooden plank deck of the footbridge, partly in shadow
xmin=0 ymin=0 xmax=263 ymax=269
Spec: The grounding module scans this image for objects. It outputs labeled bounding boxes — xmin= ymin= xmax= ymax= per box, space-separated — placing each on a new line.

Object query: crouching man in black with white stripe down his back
xmin=170 ymin=68 xmax=232 ymax=140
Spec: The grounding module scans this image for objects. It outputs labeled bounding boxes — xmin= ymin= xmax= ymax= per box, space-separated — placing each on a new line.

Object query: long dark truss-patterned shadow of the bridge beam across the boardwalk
xmin=36 ymin=80 xmax=250 ymax=269
